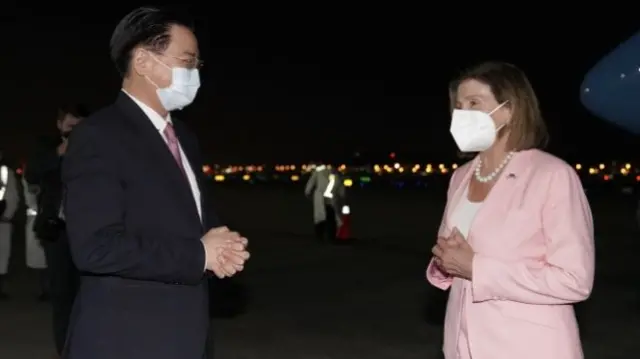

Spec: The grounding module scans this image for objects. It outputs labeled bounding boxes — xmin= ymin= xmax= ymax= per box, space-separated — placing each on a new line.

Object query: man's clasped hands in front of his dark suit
xmin=202 ymin=227 xmax=249 ymax=278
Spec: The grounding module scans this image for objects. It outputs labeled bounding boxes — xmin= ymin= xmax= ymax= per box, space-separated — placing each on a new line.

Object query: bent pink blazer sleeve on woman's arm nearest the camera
xmin=471 ymin=165 xmax=595 ymax=305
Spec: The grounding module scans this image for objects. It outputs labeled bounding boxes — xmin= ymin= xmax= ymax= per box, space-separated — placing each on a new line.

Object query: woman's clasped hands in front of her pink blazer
xmin=431 ymin=228 xmax=475 ymax=280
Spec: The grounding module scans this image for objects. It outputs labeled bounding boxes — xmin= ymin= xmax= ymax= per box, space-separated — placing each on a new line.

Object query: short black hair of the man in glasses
xmin=110 ymin=6 xmax=194 ymax=77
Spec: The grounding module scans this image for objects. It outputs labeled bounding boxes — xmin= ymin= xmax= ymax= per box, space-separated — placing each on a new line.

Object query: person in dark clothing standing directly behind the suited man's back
xmin=25 ymin=105 xmax=88 ymax=354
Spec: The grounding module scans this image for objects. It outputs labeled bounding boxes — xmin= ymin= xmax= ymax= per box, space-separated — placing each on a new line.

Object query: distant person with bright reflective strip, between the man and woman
xmin=304 ymin=164 xmax=346 ymax=241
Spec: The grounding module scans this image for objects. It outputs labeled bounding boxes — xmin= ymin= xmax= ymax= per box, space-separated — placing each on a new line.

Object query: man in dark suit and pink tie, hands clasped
xmin=62 ymin=8 xmax=249 ymax=359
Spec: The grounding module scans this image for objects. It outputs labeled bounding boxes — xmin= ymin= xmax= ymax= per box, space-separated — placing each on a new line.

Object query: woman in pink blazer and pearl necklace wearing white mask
xmin=427 ymin=63 xmax=595 ymax=359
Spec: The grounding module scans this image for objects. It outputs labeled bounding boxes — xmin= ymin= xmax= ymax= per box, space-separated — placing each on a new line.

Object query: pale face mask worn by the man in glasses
xmin=147 ymin=55 xmax=200 ymax=111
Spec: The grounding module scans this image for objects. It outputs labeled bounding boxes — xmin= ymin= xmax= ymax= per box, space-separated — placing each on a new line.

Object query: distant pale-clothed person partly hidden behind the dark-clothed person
xmin=22 ymin=177 xmax=49 ymax=301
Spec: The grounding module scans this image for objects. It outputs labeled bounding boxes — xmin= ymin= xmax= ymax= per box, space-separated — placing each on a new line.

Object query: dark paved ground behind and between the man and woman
xmin=0 ymin=188 xmax=640 ymax=359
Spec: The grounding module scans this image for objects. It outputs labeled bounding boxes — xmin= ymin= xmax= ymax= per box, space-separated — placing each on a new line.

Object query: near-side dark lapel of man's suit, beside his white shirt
xmin=116 ymin=92 xmax=200 ymax=228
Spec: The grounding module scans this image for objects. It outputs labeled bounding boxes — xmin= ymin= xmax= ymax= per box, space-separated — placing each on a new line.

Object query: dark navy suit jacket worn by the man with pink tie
xmin=62 ymin=93 xmax=219 ymax=359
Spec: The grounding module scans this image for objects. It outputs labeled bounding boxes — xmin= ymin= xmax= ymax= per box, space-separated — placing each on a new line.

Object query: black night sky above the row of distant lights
xmin=0 ymin=2 xmax=638 ymax=162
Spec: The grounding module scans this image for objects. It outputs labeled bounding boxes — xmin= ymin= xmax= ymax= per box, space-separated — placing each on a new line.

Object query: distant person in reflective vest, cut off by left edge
xmin=0 ymin=151 xmax=20 ymax=300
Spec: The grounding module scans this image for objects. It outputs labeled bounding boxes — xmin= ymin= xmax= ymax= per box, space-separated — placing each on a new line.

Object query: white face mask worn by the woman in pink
xmin=450 ymin=101 xmax=507 ymax=152
